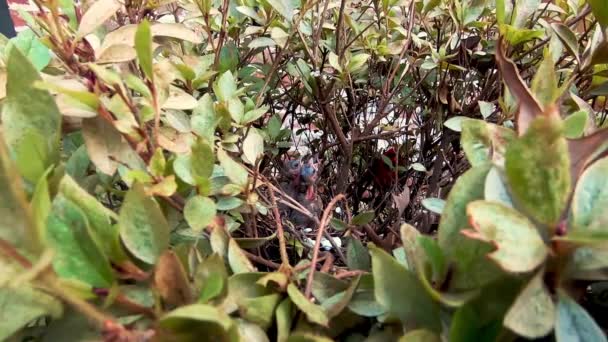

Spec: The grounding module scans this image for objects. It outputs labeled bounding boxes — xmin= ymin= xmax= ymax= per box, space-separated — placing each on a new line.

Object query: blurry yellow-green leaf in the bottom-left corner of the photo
xmin=0 ymin=286 xmax=63 ymax=341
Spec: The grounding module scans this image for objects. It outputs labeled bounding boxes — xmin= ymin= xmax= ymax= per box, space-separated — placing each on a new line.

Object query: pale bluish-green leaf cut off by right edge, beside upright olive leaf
xmin=571 ymin=158 xmax=608 ymax=230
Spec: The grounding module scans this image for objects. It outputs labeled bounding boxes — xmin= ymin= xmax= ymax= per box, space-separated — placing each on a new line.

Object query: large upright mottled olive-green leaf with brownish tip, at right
xmin=505 ymin=117 xmax=570 ymax=226
